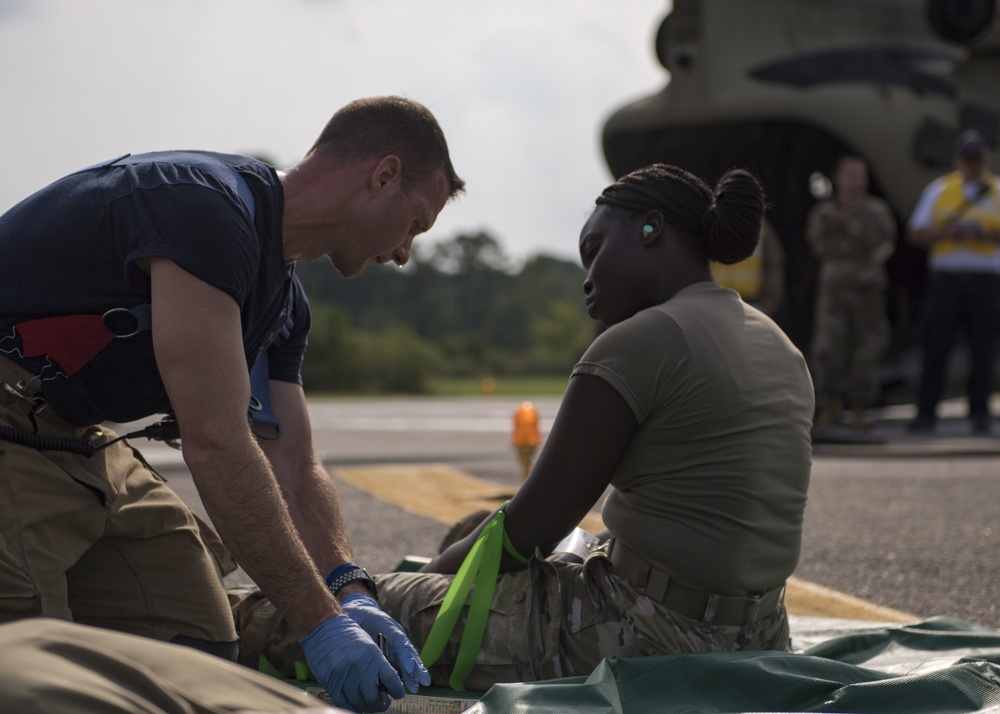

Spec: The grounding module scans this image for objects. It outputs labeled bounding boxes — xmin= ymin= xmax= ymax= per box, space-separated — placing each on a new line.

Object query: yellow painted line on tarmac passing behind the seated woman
xmin=331 ymin=464 xmax=921 ymax=622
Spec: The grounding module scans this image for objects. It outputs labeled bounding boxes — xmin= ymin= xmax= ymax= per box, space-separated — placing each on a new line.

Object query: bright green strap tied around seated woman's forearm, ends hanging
xmin=420 ymin=503 xmax=528 ymax=690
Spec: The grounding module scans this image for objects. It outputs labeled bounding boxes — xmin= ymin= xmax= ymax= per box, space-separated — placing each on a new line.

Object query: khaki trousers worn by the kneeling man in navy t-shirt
xmin=0 ymin=357 xmax=236 ymax=642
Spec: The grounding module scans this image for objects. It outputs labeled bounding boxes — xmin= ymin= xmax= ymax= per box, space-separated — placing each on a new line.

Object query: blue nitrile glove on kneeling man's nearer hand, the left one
xmin=299 ymin=615 xmax=406 ymax=712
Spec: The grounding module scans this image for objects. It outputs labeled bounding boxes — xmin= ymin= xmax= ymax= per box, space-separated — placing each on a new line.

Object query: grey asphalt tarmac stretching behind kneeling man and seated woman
xmin=129 ymin=397 xmax=1000 ymax=627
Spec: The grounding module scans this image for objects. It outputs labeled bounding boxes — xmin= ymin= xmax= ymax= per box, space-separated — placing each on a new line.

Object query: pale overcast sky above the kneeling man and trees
xmin=0 ymin=0 xmax=670 ymax=259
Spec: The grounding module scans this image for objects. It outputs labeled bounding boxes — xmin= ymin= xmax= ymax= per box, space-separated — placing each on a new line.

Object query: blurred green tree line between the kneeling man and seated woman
xmin=296 ymin=232 xmax=596 ymax=393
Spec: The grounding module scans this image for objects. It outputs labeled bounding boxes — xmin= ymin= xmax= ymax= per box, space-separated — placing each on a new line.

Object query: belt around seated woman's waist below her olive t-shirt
xmin=608 ymin=538 xmax=785 ymax=627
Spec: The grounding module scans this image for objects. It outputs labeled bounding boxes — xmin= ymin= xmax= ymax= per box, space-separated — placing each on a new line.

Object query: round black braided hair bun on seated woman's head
xmin=701 ymin=169 xmax=764 ymax=265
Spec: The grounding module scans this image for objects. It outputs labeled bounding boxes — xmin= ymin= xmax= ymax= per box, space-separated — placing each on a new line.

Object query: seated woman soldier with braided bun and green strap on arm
xmin=377 ymin=164 xmax=813 ymax=690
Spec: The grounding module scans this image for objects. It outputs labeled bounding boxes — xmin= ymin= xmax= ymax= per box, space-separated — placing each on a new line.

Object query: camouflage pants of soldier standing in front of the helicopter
xmin=811 ymin=285 xmax=889 ymax=407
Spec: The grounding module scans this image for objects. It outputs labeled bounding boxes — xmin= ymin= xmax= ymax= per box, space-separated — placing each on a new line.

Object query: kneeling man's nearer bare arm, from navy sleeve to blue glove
xmin=149 ymin=258 xmax=341 ymax=635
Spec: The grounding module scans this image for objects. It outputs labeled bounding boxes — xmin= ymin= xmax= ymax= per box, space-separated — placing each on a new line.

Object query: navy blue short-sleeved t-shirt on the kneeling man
xmin=0 ymin=152 xmax=309 ymax=424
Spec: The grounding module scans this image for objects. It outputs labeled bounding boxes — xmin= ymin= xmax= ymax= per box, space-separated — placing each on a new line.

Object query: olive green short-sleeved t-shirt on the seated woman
xmin=573 ymin=282 xmax=814 ymax=595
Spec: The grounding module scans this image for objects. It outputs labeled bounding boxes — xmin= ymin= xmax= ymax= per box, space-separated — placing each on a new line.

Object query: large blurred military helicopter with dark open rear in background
xmin=603 ymin=0 xmax=1000 ymax=370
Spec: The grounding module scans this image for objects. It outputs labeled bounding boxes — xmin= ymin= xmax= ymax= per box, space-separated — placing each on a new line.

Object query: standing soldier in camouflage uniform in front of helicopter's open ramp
xmin=806 ymin=156 xmax=897 ymax=430
